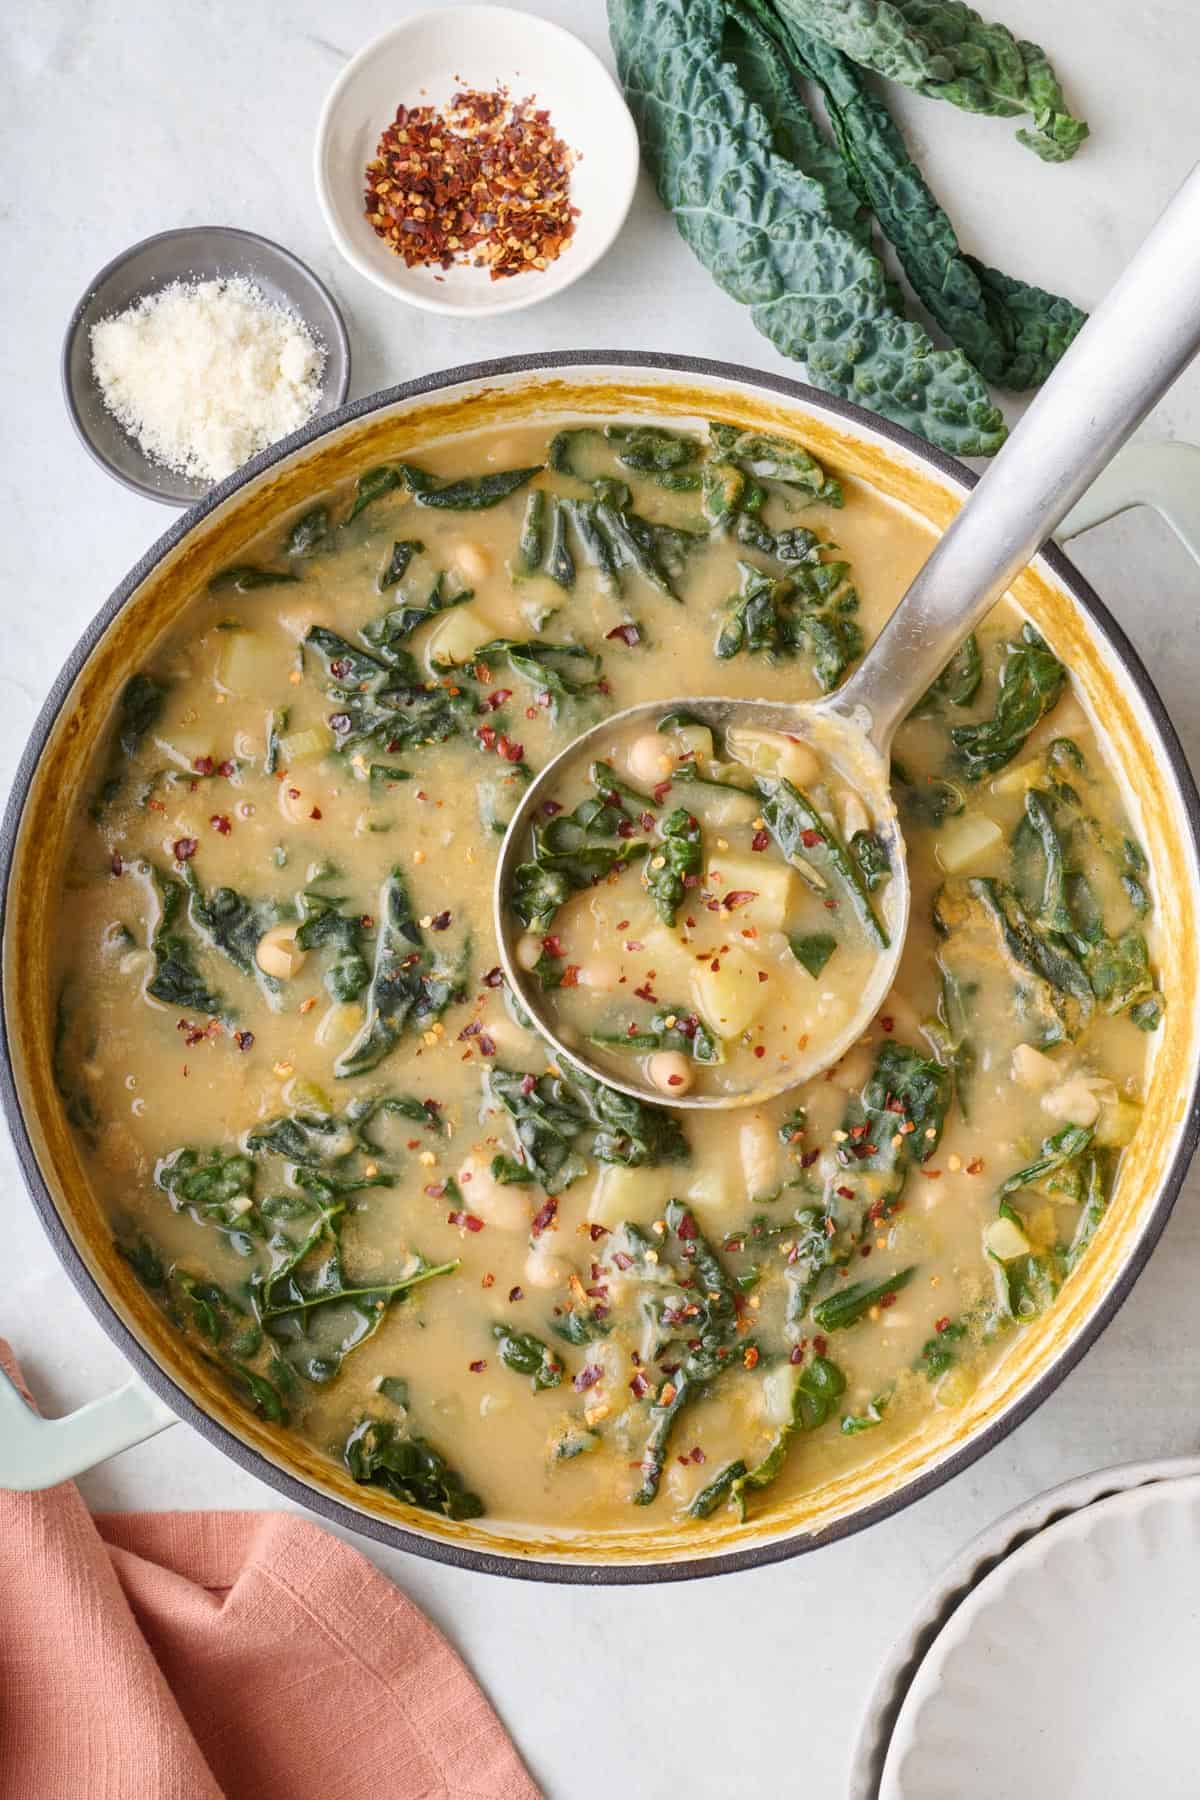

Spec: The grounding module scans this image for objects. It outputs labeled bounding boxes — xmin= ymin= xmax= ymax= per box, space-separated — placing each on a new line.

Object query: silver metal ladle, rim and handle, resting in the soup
xmin=495 ymin=166 xmax=1200 ymax=1109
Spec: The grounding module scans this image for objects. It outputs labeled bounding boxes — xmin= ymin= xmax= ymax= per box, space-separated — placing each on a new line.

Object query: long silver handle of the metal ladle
xmin=828 ymin=164 xmax=1200 ymax=752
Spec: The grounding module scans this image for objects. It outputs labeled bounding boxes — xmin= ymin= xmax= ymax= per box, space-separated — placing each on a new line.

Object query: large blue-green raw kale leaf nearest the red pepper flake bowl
xmin=608 ymin=0 xmax=1004 ymax=455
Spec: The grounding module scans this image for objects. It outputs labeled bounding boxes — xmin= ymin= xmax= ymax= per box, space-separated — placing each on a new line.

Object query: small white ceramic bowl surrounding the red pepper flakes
xmin=315 ymin=5 xmax=637 ymax=319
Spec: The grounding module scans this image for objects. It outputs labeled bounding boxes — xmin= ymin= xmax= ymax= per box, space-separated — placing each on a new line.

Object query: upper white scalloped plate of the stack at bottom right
xmin=880 ymin=1476 xmax=1200 ymax=1800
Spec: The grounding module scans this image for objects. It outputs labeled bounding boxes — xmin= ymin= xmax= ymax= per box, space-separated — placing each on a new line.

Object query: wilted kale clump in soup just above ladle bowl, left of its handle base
xmin=714 ymin=562 xmax=862 ymax=693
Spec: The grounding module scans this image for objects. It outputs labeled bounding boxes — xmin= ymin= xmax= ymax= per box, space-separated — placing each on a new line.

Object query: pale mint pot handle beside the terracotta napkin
xmin=0 ymin=1370 xmax=176 ymax=1494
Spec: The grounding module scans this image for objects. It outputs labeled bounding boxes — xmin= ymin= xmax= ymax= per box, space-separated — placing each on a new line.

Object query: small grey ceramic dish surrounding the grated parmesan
xmin=63 ymin=225 xmax=351 ymax=506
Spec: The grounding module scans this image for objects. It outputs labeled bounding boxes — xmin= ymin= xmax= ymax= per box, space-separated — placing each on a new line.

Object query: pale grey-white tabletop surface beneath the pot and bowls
xmin=0 ymin=0 xmax=1200 ymax=1800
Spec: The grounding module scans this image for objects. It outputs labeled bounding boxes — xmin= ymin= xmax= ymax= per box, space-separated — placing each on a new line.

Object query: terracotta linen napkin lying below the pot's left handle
xmin=0 ymin=1341 xmax=538 ymax=1800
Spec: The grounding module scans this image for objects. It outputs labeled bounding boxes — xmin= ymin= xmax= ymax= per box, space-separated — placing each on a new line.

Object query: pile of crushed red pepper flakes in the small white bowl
xmin=363 ymin=86 xmax=578 ymax=281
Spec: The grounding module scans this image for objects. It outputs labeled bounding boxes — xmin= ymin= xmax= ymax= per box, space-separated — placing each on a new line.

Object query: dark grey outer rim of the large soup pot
xmin=0 ymin=349 xmax=1200 ymax=1586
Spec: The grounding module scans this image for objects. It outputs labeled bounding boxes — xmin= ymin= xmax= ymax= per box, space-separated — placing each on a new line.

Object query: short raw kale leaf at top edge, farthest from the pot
xmin=775 ymin=0 xmax=1088 ymax=162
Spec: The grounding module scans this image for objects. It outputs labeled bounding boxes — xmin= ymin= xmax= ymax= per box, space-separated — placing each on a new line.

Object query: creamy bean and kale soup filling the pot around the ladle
xmin=56 ymin=425 xmax=1160 ymax=1534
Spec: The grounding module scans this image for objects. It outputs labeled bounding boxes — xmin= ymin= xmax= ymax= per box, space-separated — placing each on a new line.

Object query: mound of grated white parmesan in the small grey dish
xmin=92 ymin=275 xmax=326 ymax=481
